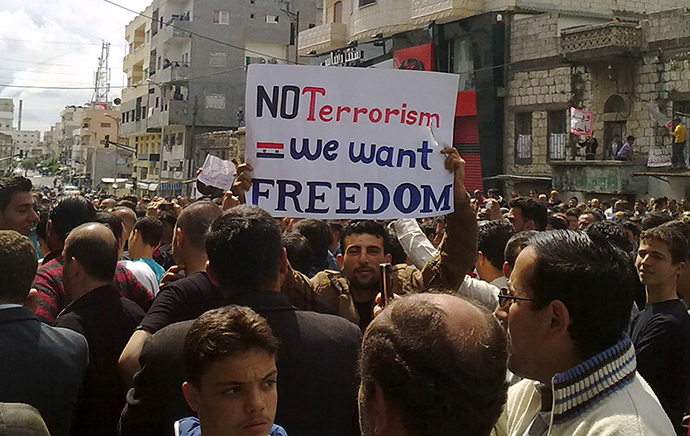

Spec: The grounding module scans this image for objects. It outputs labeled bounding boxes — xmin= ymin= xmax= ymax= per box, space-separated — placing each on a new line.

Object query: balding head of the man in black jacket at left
xmin=62 ymin=223 xmax=119 ymax=299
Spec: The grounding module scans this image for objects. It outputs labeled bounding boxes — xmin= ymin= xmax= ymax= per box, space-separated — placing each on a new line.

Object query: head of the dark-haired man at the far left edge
xmin=0 ymin=177 xmax=38 ymax=236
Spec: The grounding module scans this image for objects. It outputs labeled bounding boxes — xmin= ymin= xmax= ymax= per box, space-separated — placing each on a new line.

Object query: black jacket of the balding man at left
xmin=55 ymin=285 xmax=144 ymax=436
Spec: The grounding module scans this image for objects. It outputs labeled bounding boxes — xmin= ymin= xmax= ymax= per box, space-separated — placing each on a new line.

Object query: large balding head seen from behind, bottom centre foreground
xmin=359 ymin=294 xmax=506 ymax=436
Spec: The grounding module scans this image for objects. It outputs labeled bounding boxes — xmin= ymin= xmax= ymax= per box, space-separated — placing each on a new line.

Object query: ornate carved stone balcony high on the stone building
xmin=561 ymin=22 xmax=643 ymax=62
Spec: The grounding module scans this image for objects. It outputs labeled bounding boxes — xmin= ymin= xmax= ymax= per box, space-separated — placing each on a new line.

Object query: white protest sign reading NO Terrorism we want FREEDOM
xmin=245 ymin=65 xmax=458 ymax=219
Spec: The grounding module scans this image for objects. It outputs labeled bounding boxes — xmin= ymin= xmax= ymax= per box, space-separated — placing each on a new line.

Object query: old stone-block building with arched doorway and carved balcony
xmin=505 ymin=5 xmax=690 ymax=198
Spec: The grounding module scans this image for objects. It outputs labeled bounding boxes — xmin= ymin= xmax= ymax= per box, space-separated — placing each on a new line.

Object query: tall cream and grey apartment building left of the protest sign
xmin=122 ymin=0 xmax=317 ymax=195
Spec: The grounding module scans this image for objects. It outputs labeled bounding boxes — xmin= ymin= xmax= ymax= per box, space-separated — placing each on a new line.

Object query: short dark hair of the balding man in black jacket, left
xmin=63 ymin=223 xmax=118 ymax=281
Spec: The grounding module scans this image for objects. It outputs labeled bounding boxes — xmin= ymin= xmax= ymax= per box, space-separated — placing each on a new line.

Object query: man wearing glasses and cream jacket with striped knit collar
xmin=495 ymin=230 xmax=674 ymax=436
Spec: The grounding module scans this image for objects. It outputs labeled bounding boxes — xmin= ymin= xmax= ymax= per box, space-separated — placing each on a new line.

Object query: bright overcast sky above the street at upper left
xmin=0 ymin=0 xmax=150 ymax=132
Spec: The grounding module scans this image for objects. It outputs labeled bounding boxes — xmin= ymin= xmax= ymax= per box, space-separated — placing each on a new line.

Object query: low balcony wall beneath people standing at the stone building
xmin=551 ymin=160 xmax=647 ymax=195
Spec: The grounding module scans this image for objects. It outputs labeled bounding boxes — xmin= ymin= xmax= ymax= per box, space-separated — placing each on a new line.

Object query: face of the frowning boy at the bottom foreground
xmin=182 ymin=348 xmax=278 ymax=436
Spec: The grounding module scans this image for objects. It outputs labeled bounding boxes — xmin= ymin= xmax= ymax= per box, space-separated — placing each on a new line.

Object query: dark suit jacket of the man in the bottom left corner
xmin=0 ymin=307 xmax=89 ymax=436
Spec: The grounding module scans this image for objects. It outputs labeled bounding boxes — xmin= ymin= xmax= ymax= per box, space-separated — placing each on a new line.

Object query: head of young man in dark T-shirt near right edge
xmin=635 ymin=223 xmax=688 ymax=290
